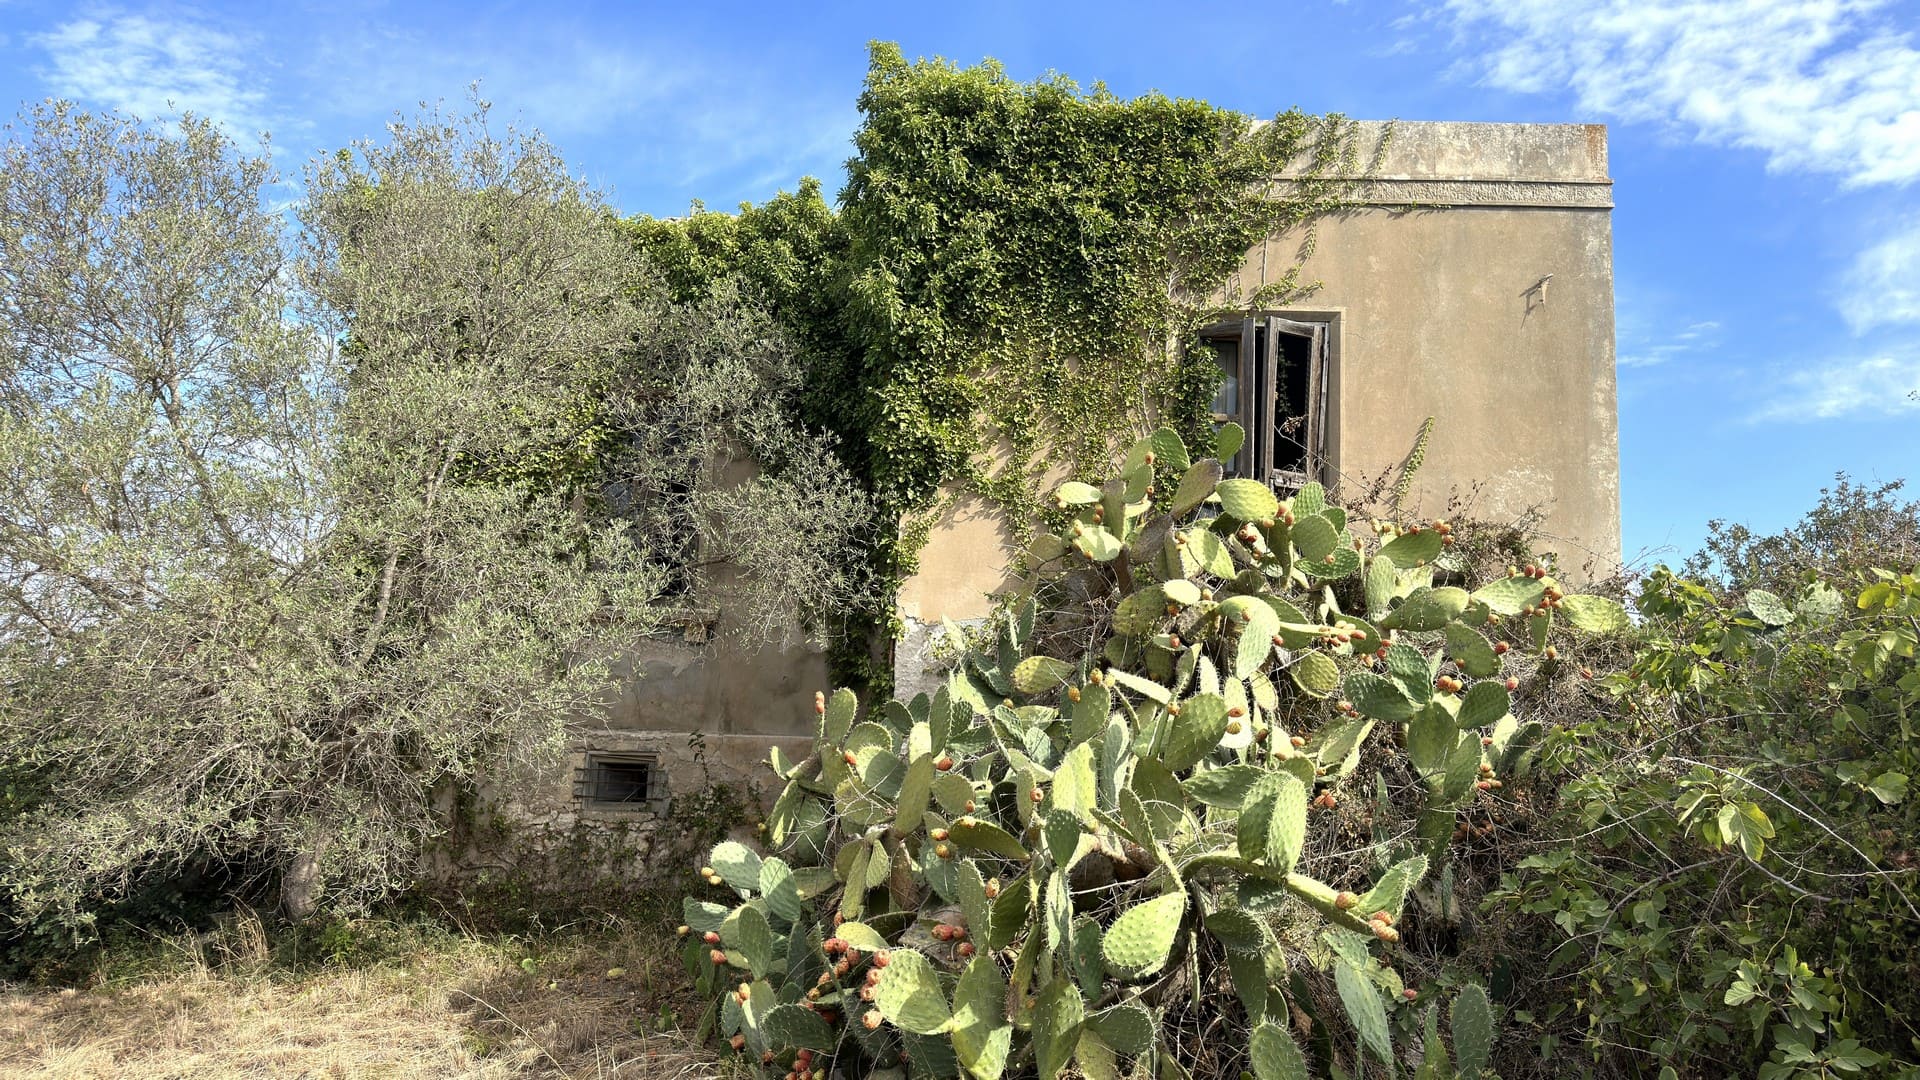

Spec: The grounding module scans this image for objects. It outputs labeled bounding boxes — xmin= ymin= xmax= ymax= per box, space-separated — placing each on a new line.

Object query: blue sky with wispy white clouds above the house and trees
xmin=0 ymin=0 xmax=1920 ymax=561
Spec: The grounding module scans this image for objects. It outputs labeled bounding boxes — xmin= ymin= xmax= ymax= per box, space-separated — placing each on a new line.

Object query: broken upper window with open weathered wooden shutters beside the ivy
xmin=1200 ymin=315 xmax=1329 ymax=490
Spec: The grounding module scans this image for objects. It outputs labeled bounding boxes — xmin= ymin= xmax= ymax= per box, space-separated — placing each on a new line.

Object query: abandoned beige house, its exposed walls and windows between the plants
xmin=468 ymin=123 xmax=1620 ymax=876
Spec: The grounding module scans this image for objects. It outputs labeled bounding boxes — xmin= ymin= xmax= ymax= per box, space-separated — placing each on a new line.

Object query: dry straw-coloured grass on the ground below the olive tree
xmin=0 ymin=907 xmax=728 ymax=1080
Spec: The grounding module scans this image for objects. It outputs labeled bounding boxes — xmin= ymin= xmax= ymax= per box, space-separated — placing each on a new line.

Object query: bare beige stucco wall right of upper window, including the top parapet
xmin=1242 ymin=123 xmax=1620 ymax=577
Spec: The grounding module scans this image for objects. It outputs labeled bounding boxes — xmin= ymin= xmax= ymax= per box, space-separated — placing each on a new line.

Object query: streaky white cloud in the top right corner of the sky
xmin=1448 ymin=0 xmax=1920 ymax=184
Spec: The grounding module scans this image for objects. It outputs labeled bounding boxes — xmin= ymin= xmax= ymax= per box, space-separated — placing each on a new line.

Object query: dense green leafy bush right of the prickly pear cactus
xmin=1492 ymin=557 xmax=1920 ymax=1078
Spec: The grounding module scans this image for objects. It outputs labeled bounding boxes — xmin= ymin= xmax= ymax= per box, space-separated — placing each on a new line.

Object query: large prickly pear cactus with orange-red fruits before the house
xmin=682 ymin=430 xmax=1624 ymax=1080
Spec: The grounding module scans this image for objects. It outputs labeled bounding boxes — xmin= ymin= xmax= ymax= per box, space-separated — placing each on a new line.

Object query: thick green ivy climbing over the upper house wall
xmin=626 ymin=44 xmax=1363 ymax=687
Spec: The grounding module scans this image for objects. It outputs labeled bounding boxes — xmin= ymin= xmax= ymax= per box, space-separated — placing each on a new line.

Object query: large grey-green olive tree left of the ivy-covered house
xmin=0 ymin=104 xmax=858 ymax=932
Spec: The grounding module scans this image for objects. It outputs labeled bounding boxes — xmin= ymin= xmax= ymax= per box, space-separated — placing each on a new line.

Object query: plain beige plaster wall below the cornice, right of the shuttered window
xmin=1254 ymin=208 xmax=1620 ymax=575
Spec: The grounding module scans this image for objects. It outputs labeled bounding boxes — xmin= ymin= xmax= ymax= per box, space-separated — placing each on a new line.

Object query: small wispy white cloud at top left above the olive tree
xmin=29 ymin=13 xmax=271 ymax=136
